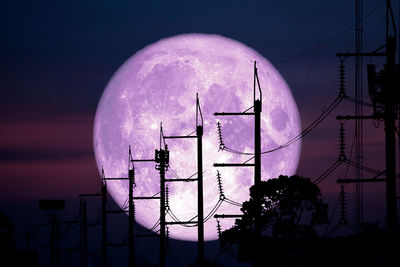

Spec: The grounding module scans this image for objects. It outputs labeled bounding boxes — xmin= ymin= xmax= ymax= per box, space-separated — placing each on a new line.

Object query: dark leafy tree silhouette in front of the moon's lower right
xmin=221 ymin=175 xmax=328 ymax=245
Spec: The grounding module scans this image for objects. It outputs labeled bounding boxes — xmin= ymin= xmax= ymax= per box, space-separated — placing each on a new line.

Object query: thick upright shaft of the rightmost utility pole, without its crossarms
xmin=384 ymin=37 xmax=398 ymax=233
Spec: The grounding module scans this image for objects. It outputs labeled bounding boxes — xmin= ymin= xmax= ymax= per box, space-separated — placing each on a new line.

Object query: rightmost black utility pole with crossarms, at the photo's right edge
xmin=336 ymin=0 xmax=400 ymax=233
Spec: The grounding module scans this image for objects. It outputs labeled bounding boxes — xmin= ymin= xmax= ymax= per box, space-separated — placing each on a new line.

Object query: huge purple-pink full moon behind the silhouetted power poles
xmin=93 ymin=34 xmax=301 ymax=241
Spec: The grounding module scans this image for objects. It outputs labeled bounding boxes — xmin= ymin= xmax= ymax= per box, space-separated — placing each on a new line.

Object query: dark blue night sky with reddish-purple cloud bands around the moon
xmin=0 ymin=0 xmax=398 ymax=266
